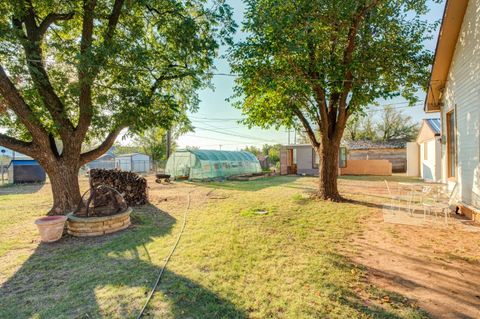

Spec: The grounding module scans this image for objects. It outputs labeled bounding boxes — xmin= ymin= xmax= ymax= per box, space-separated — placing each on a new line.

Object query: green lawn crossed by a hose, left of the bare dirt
xmin=0 ymin=177 xmax=425 ymax=318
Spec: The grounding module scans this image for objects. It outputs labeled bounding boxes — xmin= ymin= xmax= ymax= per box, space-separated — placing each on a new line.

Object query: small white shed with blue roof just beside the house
xmin=417 ymin=118 xmax=442 ymax=182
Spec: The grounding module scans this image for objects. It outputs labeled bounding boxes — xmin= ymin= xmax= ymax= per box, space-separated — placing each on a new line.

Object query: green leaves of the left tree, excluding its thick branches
xmin=0 ymin=0 xmax=235 ymax=138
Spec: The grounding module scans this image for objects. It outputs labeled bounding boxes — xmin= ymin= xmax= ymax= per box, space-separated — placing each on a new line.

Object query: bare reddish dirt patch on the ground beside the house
xmin=345 ymin=179 xmax=480 ymax=318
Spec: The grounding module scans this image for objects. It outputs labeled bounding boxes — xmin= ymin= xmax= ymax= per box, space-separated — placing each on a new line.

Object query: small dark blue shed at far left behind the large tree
xmin=8 ymin=159 xmax=47 ymax=184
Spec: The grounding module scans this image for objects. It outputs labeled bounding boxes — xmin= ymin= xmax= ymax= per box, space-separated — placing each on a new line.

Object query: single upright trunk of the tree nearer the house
xmin=317 ymin=142 xmax=342 ymax=202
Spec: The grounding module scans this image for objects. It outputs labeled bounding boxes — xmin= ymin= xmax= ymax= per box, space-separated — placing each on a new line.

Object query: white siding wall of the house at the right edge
xmin=442 ymin=0 xmax=480 ymax=208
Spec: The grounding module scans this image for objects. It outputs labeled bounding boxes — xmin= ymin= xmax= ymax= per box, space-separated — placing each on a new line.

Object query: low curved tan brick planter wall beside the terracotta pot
xmin=67 ymin=207 xmax=132 ymax=237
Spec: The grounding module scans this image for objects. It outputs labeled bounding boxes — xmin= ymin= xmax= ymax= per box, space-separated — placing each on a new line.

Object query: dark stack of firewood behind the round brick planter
xmin=90 ymin=169 xmax=148 ymax=206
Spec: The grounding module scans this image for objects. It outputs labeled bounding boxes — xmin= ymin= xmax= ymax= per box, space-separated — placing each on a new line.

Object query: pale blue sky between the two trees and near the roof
xmin=177 ymin=0 xmax=444 ymax=150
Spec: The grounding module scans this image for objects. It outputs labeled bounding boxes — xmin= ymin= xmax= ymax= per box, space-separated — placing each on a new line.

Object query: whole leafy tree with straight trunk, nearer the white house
xmin=230 ymin=0 xmax=436 ymax=201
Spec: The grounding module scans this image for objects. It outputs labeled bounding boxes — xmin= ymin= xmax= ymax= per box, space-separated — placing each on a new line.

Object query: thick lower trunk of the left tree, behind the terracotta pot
xmin=43 ymin=161 xmax=81 ymax=215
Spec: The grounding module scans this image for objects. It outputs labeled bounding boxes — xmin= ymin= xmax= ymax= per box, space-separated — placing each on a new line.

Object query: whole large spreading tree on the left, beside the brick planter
xmin=0 ymin=0 xmax=235 ymax=214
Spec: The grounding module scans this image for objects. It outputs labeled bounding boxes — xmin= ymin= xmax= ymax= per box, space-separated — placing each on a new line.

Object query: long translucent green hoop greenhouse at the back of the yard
xmin=165 ymin=150 xmax=262 ymax=180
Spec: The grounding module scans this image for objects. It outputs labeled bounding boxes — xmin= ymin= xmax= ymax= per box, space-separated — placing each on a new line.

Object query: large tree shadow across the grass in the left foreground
xmin=0 ymin=205 xmax=246 ymax=318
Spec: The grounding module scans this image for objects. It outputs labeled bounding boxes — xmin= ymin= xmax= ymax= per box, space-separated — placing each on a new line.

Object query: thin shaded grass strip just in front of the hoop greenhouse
xmin=189 ymin=176 xmax=299 ymax=192
